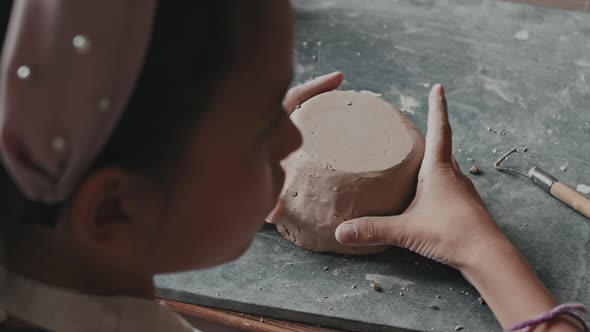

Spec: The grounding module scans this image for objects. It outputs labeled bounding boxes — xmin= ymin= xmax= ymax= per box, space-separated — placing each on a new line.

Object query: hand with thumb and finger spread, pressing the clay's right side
xmin=336 ymin=84 xmax=512 ymax=268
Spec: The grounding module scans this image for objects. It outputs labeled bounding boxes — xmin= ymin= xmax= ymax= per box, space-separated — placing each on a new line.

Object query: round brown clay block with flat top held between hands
xmin=270 ymin=91 xmax=424 ymax=254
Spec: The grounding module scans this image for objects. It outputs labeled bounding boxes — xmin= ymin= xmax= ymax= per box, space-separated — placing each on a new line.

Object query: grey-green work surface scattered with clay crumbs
xmin=156 ymin=0 xmax=590 ymax=331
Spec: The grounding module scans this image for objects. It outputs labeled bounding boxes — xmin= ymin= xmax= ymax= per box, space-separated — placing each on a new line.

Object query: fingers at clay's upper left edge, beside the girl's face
xmin=283 ymin=72 xmax=344 ymax=114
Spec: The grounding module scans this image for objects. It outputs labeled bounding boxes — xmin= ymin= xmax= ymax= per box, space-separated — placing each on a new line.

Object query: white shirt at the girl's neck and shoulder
xmin=0 ymin=265 xmax=197 ymax=332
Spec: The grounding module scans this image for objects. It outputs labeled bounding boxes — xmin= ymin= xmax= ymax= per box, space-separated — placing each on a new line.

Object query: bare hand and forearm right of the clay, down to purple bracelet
xmin=336 ymin=84 xmax=578 ymax=332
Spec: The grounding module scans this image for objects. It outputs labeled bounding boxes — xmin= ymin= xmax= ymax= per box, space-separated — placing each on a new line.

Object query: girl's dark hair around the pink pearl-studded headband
xmin=0 ymin=0 xmax=241 ymax=225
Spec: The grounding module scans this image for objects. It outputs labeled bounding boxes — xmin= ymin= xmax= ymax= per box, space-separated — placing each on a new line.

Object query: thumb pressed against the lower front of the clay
xmin=335 ymin=215 xmax=407 ymax=246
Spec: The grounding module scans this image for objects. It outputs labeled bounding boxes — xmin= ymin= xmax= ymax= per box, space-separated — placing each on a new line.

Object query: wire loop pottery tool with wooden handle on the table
xmin=494 ymin=149 xmax=590 ymax=219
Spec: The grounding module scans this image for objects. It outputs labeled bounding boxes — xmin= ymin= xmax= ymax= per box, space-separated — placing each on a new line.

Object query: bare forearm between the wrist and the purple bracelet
xmin=461 ymin=240 xmax=580 ymax=332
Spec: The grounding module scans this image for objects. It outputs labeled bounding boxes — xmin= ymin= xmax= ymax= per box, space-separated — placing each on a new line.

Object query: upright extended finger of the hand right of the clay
xmin=424 ymin=84 xmax=453 ymax=165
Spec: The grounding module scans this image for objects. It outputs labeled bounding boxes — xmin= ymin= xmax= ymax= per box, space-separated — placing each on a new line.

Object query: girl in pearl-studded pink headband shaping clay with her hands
xmin=0 ymin=0 xmax=581 ymax=332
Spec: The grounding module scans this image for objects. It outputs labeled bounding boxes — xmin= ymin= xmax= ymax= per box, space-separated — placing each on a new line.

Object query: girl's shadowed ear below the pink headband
xmin=69 ymin=167 xmax=140 ymax=258
